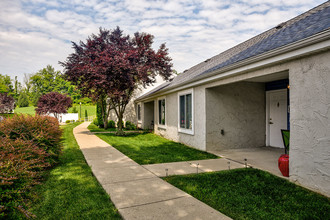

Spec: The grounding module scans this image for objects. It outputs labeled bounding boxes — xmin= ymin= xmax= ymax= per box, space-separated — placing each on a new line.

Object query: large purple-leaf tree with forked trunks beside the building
xmin=60 ymin=27 xmax=172 ymax=134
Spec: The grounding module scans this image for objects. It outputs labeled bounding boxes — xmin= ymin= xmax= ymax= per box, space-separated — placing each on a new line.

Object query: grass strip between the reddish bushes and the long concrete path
xmin=30 ymin=123 xmax=121 ymax=219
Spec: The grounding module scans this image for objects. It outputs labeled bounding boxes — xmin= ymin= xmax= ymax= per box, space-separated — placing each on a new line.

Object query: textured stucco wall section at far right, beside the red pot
xmin=290 ymin=52 xmax=330 ymax=196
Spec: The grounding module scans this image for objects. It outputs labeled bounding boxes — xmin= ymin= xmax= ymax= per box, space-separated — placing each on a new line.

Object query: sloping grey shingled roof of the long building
xmin=137 ymin=1 xmax=330 ymax=100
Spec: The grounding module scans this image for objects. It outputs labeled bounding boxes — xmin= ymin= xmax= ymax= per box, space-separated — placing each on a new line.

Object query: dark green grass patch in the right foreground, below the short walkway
xmin=164 ymin=169 xmax=330 ymax=219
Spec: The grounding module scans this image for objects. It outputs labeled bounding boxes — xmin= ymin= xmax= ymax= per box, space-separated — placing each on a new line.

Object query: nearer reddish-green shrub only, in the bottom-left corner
xmin=0 ymin=136 xmax=50 ymax=218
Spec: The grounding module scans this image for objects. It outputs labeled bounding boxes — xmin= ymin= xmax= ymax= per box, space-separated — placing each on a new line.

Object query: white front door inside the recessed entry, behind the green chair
xmin=268 ymin=89 xmax=287 ymax=148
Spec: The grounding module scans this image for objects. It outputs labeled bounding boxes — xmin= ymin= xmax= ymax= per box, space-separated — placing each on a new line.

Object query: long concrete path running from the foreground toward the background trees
xmin=73 ymin=122 xmax=230 ymax=220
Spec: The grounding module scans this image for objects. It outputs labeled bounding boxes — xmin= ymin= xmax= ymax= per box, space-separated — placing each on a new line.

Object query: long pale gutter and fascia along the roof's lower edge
xmin=135 ymin=29 xmax=330 ymax=102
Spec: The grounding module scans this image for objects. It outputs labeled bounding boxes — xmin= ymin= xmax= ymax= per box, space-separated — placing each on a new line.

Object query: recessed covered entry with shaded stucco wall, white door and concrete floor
xmin=206 ymin=72 xmax=290 ymax=175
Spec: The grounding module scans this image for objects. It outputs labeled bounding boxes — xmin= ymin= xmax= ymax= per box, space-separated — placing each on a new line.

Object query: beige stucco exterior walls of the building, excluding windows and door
xmin=136 ymin=50 xmax=330 ymax=196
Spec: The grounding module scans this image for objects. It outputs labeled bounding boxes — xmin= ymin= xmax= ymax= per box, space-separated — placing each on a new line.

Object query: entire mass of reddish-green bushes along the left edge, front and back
xmin=0 ymin=115 xmax=62 ymax=218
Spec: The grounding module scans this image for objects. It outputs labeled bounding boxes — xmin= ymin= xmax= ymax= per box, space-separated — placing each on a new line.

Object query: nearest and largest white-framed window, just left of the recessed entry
xmin=178 ymin=90 xmax=193 ymax=134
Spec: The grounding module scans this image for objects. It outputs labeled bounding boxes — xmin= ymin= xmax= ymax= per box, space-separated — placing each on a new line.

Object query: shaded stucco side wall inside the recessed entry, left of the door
xmin=206 ymin=82 xmax=266 ymax=150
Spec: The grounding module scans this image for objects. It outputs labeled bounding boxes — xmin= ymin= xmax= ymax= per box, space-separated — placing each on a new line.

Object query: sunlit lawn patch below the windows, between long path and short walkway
xmin=96 ymin=133 xmax=218 ymax=164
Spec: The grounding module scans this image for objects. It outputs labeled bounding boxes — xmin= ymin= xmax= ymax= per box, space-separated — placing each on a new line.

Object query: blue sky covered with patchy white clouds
xmin=0 ymin=0 xmax=325 ymax=82
